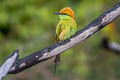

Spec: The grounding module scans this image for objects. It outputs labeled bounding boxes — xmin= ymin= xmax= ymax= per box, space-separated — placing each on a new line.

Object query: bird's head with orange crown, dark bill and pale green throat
xmin=55 ymin=7 xmax=74 ymax=19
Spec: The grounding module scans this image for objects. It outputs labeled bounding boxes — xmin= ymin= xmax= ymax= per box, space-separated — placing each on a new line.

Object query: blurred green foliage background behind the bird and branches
xmin=0 ymin=0 xmax=120 ymax=80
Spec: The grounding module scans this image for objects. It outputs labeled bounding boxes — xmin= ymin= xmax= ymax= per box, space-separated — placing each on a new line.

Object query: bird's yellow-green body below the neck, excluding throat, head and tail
xmin=56 ymin=19 xmax=76 ymax=42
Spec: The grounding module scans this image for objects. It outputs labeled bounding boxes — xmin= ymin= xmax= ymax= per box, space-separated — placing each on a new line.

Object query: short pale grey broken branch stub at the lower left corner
xmin=0 ymin=50 xmax=18 ymax=80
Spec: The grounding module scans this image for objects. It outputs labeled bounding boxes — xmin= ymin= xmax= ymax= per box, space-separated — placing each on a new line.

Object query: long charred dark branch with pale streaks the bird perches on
xmin=9 ymin=2 xmax=120 ymax=74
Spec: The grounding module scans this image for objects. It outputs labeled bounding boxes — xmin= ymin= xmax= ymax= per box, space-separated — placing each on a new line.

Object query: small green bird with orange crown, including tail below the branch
xmin=54 ymin=7 xmax=77 ymax=76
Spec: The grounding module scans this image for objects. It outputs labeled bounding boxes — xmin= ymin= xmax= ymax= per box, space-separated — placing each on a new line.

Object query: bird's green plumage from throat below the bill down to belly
xmin=56 ymin=15 xmax=77 ymax=42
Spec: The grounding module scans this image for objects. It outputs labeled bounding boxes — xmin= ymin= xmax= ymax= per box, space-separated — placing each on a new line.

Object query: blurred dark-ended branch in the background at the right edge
xmin=102 ymin=38 xmax=120 ymax=54
